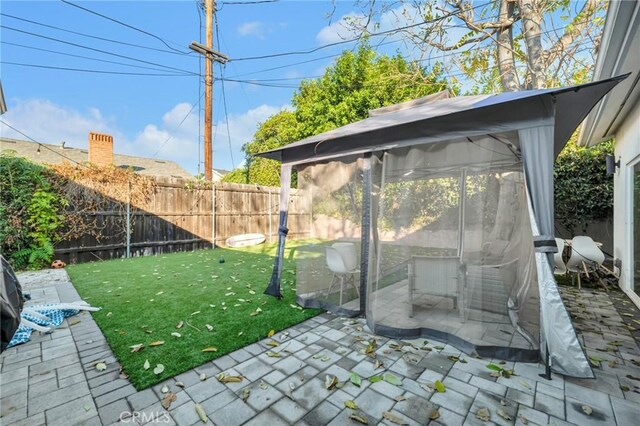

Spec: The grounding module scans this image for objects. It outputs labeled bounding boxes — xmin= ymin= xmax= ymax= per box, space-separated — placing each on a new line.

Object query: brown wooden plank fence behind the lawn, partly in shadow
xmin=55 ymin=178 xmax=311 ymax=263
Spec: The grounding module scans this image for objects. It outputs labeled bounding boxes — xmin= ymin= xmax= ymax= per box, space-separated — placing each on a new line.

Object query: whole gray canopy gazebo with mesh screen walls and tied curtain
xmin=259 ymin=77 xmax=624 ymax=377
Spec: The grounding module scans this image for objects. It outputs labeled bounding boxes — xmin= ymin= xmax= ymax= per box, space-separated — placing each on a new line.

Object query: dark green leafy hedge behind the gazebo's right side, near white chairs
xmin=554 ymin=141 xmax=613 ymax=233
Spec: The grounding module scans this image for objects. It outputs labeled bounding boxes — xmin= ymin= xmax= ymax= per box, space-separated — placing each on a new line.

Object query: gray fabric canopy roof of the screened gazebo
xmin=256 ymin=75 xmax=626 ymax=163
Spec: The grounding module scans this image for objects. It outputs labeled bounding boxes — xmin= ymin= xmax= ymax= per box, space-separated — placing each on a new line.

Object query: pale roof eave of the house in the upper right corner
xmin=578 ymin=0 xmax=640 ymax=146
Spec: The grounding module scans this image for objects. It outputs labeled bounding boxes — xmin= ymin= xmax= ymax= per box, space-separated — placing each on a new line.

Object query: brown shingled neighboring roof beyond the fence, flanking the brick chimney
xmin=0 ymin=138 xmax=192 ymax=178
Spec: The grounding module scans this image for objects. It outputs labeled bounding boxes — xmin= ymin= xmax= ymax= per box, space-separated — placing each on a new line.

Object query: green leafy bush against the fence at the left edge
xmin=0 ymin=155 xmax=67 ymax=269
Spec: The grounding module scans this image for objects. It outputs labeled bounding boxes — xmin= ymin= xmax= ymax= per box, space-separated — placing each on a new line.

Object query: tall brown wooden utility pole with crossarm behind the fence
xmin=189 ymin=0 xmax=229 ymax=181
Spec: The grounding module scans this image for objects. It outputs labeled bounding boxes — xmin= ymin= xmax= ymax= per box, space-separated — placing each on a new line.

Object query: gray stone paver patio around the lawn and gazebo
xmin=0 ymin=270 xmax=640 ymax=426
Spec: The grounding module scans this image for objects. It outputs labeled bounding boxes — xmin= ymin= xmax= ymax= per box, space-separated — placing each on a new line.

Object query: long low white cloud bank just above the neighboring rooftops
xmin=0 ymin=99 xmax=285 ymax=174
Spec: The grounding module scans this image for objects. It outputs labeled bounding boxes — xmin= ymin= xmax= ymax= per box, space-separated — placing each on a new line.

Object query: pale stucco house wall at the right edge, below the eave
xmin=613 ymin=100 xmax=640 ymax=306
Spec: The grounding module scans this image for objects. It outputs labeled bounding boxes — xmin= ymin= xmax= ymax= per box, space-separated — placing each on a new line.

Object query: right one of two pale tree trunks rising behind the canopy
xmin=520 ymin=0 xmax=546 ymax=89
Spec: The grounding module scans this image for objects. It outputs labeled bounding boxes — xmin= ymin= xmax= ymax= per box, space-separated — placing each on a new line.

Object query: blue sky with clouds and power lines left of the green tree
xmin=0 ymin=0 xmax=412 ymax=173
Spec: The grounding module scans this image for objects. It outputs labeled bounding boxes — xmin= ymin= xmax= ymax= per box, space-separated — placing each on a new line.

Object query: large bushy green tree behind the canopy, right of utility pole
xmin=224 ymin=41 xmax=456 ymax=186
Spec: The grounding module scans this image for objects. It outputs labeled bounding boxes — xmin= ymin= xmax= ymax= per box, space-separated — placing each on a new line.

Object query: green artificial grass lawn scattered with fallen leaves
xmin=67 ymin=241 xmax=321 ymax=390
